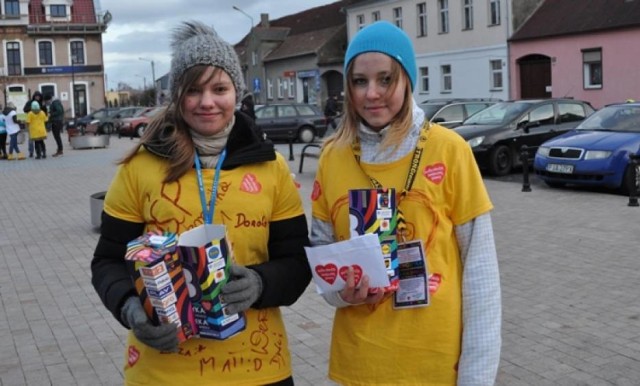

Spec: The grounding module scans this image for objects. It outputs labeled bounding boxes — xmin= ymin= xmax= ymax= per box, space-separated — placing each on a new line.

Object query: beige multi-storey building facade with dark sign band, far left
xmin=0 ymin=0 xmax=111 ymax=117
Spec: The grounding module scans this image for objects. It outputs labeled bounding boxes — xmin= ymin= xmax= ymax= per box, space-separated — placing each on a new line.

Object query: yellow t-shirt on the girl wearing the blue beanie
xmin=312 ymin=125 xmax=492 ymax=385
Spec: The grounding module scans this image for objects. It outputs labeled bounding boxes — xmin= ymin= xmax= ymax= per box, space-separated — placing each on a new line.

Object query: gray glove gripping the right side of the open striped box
xmin=222 ymin=264 xmax=262 ymax=314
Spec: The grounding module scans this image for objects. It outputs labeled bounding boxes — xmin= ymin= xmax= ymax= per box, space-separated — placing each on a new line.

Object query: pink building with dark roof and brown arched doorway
xmin=509 ymin=0 xmax=640 ymax=108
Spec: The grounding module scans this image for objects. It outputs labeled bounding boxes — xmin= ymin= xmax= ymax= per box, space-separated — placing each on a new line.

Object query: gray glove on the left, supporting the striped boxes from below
xmin=120 ymin=296 xmax=178 ymax=352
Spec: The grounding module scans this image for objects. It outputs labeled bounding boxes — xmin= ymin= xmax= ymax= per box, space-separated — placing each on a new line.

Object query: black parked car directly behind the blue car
xmin=454 ymin=99 xmax=595 ymax=176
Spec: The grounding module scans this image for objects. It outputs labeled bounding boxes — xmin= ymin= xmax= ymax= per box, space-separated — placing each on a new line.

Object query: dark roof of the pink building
xmin=509 ymin=0 xmax=640 ymax=41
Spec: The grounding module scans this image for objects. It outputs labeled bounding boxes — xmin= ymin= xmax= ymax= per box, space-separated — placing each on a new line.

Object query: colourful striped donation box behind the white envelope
xmin=349 ymin=188 xmax=399 ymax=292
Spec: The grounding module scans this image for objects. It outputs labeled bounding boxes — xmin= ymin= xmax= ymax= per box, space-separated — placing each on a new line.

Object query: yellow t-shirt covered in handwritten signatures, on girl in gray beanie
xmin=104 ymin=150 xmax=304 ymax=385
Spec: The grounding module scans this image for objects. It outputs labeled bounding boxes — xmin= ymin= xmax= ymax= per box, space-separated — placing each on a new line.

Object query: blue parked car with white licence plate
xmin=533 ymin=103 xmax=640 ymax=193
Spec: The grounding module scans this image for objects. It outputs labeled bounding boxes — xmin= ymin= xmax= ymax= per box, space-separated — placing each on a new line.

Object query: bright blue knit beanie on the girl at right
xmin=344 ymin=21 xmax=417 ymax=91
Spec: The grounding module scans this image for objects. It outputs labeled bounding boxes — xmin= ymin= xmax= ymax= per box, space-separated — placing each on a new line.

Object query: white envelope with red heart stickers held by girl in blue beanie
xmin=305 ymin=234 xmax=389 ymax=294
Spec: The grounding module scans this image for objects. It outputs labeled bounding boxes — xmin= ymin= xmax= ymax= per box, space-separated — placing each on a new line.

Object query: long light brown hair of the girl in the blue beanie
xmin=324 ymin=59 xmax=413 ymax=152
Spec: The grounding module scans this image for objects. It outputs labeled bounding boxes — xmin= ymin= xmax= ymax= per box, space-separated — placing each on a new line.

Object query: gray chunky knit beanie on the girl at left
xmin=169 ymin=21 xmax=245 ymax=102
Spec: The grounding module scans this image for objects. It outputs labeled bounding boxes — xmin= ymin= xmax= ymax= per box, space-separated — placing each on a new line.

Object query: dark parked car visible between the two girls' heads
xmin=256 ymin=103 xmax=327 ymax=143
